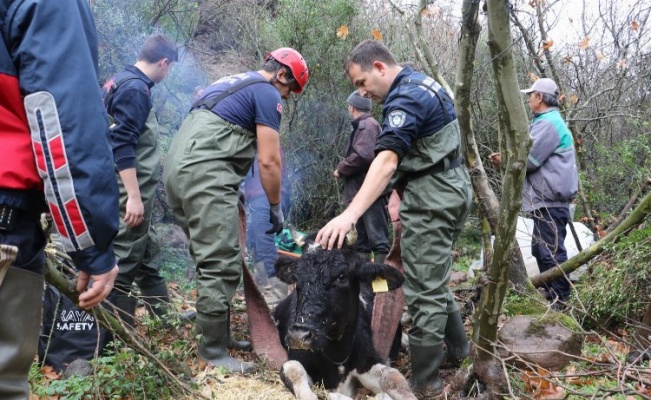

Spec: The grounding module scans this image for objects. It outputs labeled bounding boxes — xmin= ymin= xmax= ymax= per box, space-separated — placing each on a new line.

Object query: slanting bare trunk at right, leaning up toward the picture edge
xmin=531 ymin=192 xmax=651 ymax=287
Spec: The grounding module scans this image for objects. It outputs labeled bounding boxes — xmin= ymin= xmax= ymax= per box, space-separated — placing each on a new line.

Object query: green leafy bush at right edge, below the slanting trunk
xmin=577 ymin=224 xmax=651 ymax=328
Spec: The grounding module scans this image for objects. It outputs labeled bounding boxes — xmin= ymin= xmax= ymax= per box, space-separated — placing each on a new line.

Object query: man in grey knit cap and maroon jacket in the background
xmin=334 ymin=90 xmax=390 ymax=263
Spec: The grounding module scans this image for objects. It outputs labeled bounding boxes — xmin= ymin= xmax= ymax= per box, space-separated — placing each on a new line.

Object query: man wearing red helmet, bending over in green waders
xmin=163 ymin=48 xmax=309 ymax=372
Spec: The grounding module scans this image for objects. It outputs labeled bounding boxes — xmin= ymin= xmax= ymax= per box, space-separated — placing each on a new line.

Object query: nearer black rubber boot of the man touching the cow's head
xmin=409 ymin=340 xmax=444 ymax=399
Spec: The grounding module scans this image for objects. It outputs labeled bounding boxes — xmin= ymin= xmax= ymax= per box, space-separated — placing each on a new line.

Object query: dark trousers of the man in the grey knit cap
xmin=355 ymin=196 xmax=389 ymax=254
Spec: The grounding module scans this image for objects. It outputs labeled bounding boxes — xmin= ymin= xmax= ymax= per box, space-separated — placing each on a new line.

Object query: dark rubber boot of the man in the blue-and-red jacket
xmin=0 ymin=267 xmax=43 ymax=400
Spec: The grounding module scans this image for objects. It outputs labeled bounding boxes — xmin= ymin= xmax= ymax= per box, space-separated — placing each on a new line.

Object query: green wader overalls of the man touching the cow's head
xmin=397 ymin=120 xmax=472 ymax=346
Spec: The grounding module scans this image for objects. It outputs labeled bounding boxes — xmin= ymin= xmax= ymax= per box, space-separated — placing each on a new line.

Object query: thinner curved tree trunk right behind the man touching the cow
xmin=454 ymin=0 xmax=529 ymax=291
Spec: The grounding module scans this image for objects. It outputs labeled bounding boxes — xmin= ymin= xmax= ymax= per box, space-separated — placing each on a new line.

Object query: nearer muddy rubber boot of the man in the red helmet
xmin=195 ymin=313 xmax=255 ymax=374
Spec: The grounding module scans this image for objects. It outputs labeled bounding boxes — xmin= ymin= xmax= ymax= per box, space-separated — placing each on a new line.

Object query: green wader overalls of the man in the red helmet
xmin=163 ymin=110 xmax=256 ymax=318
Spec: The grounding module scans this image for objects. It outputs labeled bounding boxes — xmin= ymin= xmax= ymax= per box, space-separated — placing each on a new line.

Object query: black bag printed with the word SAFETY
xmin=38 ymin=283 xmax=115 ymax=371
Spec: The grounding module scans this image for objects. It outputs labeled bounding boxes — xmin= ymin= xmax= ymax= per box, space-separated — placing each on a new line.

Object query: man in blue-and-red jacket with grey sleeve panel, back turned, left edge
xmin=0 ymin=0 xmax=118 ymax=400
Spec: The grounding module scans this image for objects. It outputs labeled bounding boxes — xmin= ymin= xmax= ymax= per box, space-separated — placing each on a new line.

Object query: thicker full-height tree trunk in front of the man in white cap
xmin=473 ymin=0 xmax=531 ymax=395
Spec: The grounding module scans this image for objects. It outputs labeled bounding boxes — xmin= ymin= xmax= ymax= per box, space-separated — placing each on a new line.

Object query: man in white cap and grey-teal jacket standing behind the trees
xmin=490 ymin=78 xmax=579 ymax=309
